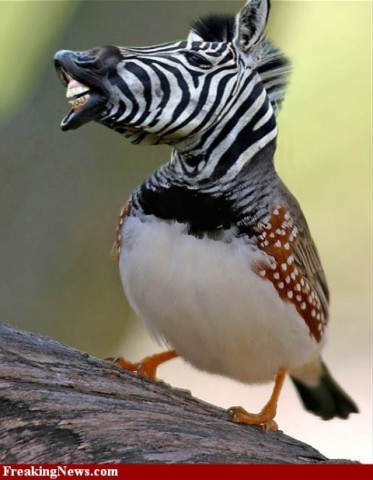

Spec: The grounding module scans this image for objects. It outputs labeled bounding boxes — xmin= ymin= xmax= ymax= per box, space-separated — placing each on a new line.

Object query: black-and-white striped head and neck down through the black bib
xmin=55 ymin=0 xmax=289 ymax=233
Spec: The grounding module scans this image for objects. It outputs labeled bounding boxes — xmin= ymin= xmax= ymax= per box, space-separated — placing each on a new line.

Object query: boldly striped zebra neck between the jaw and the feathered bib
xmin=169 ymin=73 xmax=277 ymax=185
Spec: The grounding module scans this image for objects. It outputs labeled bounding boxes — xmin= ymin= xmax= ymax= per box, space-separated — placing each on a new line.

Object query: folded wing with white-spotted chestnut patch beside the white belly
xmin=253 ymin=202 xmax=329 ymax=342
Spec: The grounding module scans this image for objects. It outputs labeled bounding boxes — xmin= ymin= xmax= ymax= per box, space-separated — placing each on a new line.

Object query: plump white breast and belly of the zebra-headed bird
xmin=120 ymin=217 xmax=322 ymax=383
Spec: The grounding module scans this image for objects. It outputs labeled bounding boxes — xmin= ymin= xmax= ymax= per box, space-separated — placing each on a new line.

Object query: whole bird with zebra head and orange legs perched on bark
xmin=55 ymin=0 xmax=358 ymax=430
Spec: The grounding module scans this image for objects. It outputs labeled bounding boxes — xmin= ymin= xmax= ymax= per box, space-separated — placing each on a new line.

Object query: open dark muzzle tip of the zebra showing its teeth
xmin=55 ymin=50 xmax=107 ymax=131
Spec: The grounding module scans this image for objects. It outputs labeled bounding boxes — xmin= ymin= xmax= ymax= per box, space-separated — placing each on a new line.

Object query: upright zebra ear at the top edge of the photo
xmin=234 ymin=0 xmax=270 ymax=52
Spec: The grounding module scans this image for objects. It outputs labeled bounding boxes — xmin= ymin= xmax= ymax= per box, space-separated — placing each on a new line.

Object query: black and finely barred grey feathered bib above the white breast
xmin=132 ymin=142 xmax=280 ymax=237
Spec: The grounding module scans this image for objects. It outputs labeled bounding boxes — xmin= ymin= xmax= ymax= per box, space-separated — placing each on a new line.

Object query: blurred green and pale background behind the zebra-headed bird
xmin=0 ymin=0 xmax=372 ymax=462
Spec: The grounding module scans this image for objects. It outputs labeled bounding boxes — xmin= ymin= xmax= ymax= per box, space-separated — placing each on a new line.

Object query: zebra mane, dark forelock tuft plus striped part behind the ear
xmin=192 ymin=15 xmax=291 ymax=116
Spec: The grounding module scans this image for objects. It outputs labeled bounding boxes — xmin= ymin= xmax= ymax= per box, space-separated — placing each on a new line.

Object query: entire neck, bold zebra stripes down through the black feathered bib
xmin=133 ymin=73 xmax=279 ymax=235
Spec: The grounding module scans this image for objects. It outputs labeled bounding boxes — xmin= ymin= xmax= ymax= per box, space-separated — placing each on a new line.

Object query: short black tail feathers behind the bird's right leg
xmin=291 ymin=363 xmax=359 ymax=420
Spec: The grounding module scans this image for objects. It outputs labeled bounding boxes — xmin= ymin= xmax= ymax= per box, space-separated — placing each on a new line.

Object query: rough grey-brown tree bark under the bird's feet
xmin=0 ymin=324 xmax=350 ymax=463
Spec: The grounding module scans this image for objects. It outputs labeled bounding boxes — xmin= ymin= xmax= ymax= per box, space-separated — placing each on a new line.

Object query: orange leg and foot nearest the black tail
xmin=228 ymin=369 xmax=287 ymax=432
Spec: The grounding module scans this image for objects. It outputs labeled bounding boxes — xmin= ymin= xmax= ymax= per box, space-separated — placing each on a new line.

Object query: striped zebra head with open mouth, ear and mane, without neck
xmin=55 ymin=0 xmax=288 ymax=145
